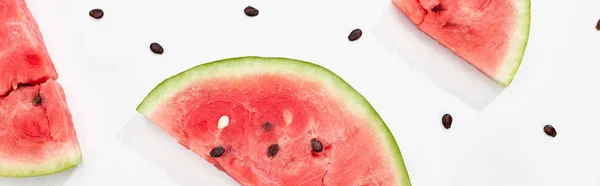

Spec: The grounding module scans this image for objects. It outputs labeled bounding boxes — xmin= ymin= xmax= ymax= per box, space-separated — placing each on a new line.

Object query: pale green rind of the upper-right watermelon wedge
xmin=494 ymin=0 xmax=531 ymax=87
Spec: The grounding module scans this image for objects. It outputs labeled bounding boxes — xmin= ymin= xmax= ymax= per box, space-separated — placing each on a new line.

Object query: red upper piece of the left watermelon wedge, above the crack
xmin=0 ymin=0 xmax=58 ymax=96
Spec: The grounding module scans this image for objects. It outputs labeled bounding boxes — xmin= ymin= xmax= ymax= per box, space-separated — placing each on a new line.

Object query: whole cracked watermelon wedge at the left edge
xmin=0 ymin=0 xmax=81 ymax=177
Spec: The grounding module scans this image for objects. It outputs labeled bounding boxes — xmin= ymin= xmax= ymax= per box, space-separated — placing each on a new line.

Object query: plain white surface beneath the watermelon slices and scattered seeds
xmin=0 ymin=0 xmax=600 ymax=186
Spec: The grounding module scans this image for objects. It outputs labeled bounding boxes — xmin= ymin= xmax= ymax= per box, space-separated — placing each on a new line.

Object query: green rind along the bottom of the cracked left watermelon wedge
xmin=0 ymin=147 xmax=82 ymax=178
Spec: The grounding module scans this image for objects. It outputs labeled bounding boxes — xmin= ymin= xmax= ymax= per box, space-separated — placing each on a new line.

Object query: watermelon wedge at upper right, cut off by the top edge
xmin=393 ymin=0 xmax=531 ymax=86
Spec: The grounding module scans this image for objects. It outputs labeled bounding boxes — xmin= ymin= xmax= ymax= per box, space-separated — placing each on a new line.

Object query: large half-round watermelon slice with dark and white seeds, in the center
xmin=137 ymin=57 xmax=410 ymax=186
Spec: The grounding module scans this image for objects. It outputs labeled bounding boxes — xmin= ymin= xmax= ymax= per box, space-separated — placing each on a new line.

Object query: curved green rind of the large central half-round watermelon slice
xmin=136 ymin=56 xmax=411 ymax=186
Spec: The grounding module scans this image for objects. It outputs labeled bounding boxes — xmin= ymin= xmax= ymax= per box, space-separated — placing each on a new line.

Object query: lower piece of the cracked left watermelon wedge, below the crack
xmin=0 ymin=80 xmax=81 ymax=177
